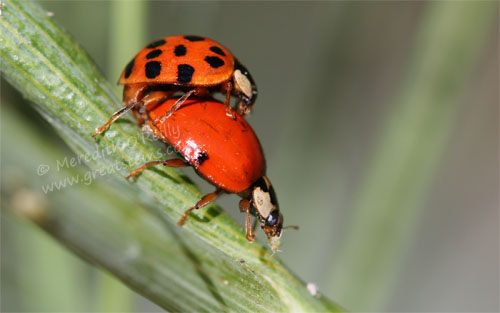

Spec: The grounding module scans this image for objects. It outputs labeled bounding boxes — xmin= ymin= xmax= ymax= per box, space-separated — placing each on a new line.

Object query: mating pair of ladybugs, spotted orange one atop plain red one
xmin=93 ymin=36 xmax=290 ymax=251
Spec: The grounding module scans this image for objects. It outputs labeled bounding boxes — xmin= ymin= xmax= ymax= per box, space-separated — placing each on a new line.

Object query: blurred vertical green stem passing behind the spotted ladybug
xmin=96 ymin=1 xmax=148 ymax=312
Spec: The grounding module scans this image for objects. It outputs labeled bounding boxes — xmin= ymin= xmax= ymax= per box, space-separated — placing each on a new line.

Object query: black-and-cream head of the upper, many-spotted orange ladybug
xmin=232 ymin=59 xmax=258 ymax=114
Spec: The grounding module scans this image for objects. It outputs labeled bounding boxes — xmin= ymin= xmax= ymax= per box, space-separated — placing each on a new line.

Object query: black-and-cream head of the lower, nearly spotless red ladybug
xmin=250 ymin=176 xmax=283 ymax=251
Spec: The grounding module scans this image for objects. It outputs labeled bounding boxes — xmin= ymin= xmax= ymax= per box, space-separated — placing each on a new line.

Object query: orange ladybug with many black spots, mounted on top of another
xmin=93 ymin=35 xmax=257 ymax=138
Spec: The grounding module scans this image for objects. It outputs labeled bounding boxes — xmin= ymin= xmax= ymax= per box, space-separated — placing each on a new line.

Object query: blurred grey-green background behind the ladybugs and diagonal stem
xmin=1 ymin=1 xmax=499 ymax=312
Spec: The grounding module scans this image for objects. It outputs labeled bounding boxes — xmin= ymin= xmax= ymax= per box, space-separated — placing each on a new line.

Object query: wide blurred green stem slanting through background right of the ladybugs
xmin=330 ymin=1 xmax=496 ymax=311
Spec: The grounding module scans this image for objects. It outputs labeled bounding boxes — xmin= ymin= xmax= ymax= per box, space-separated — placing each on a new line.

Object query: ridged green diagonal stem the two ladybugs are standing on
xmin=0 ymin=0 xmax=340 ymax=312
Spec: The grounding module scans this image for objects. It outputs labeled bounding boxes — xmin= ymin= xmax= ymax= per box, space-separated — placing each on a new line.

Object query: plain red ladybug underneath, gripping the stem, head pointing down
xmin=127 ymin=95 xmax=283 ymax=251
